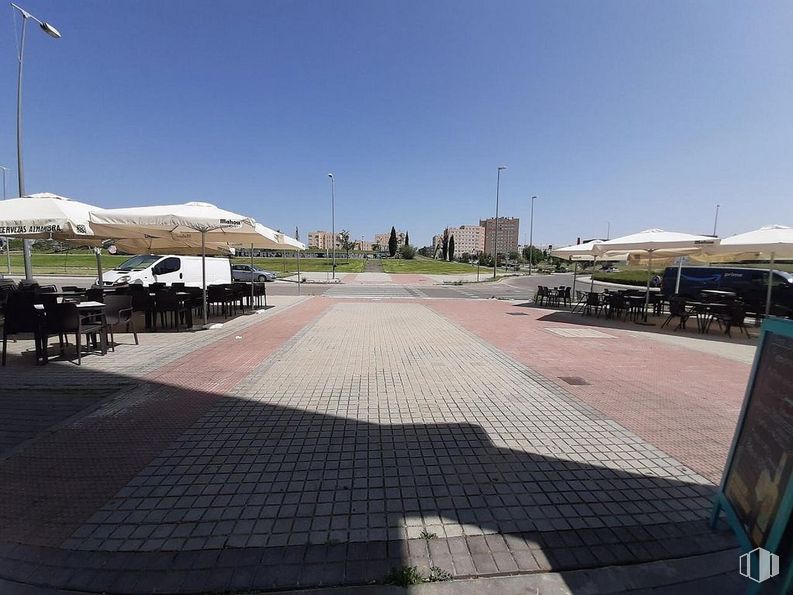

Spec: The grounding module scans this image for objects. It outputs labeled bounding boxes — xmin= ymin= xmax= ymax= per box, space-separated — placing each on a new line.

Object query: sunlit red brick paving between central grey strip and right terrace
xmin=425 ymin=300 xmax=750 ymax=483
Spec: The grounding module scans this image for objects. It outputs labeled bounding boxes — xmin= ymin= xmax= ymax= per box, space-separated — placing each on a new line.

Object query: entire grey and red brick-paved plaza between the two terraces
xmin=0 ymin=294 xmax=752 ymax=593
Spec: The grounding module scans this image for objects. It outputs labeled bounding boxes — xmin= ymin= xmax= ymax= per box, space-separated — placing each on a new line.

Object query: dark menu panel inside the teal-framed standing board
xmin=723 ymin=331 xmax=793 ymax=547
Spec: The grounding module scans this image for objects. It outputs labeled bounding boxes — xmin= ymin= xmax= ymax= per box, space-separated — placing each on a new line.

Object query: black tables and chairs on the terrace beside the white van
xmin=0 ymin=279 xmax=267 ymax=365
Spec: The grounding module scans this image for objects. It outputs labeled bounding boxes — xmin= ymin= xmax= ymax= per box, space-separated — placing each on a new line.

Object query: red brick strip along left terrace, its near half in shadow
xmin=0 ymin=299 xmax=329 ymax=546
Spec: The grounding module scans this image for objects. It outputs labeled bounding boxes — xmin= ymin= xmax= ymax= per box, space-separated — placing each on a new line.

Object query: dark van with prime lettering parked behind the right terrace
xmin=661 ymin=266 xmax=793 ymax=316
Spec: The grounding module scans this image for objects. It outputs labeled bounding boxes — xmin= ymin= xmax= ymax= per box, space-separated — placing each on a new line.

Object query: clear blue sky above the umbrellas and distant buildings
xmin=0 ymin=0 xmax=793 ymax=245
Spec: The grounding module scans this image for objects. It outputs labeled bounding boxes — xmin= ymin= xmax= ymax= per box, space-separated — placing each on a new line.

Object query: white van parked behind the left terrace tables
xmin=102 ymin=254 xmax=231 ymax=287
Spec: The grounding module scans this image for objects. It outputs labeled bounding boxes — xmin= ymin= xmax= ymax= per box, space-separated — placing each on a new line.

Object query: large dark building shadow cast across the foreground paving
xmin=0 ymin=364 xmax=734 ymax=593
